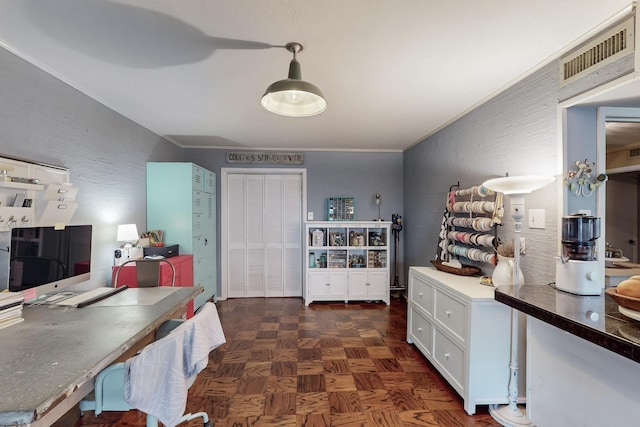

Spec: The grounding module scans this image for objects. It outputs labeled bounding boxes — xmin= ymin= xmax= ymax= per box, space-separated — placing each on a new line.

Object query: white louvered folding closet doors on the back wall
xmin=222 ymin=171 xmax=305 ymax=298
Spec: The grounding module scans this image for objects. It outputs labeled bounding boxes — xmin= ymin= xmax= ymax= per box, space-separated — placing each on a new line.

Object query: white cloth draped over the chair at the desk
xmin=124 ymin=302 xmax=226 ymax=427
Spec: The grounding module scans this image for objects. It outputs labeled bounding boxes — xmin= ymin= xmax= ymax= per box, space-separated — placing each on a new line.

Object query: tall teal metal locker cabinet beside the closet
xmin=147 ymin=162 xmax=218 ymax=309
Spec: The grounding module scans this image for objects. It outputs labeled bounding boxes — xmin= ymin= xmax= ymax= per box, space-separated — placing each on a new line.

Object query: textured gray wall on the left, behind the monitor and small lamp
xmin=0 ymin=49 xmax=182 ymax=284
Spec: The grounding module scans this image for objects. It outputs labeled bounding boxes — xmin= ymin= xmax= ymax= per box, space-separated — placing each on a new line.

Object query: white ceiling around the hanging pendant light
xmin=0 ymin=0 xmax=632 ymax=151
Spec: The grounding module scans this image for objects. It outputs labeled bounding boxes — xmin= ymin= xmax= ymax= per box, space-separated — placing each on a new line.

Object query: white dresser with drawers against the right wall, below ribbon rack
xmin=407 ymin=267 xmax=525 ymax=415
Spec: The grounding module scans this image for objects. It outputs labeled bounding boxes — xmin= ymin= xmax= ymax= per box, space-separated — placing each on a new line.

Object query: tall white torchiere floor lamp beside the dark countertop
xmin=482 ymin=175 xmax=555 ymax=427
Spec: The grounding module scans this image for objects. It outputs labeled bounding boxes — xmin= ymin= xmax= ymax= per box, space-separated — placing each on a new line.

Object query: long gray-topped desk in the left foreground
xmin=0 ymin=287 xmax=202 ymax=426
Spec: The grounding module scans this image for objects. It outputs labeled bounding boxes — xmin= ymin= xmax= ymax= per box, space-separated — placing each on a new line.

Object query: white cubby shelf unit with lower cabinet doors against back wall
xmin=304 ymin=221 xmax=391 ymax=305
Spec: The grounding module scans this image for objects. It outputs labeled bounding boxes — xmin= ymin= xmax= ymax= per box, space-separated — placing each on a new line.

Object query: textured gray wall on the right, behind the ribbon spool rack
xmin=404 ymin=62 xmax=562 ymax=284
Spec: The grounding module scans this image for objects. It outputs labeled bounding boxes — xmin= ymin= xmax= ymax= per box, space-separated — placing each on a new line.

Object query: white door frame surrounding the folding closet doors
xmin=219 ymin=168 xmax=307 ymax=300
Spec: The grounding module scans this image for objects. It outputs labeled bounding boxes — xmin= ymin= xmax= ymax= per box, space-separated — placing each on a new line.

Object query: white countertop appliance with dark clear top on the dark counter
xmin=556 ymin=214 xmax=604 ymax=295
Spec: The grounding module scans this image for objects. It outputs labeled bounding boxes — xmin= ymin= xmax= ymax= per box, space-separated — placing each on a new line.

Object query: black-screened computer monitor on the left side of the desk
xmin=9 ymin=225 xmax=92 ymax=297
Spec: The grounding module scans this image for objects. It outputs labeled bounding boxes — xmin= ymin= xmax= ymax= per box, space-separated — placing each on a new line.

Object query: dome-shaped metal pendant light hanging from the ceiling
xmin=260 ymin=42 xmax=327 ymax=117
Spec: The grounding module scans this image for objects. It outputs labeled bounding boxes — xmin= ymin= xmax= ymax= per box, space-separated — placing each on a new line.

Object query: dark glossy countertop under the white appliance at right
xmin=495 ymin=285 xmax=640 ymax=363
